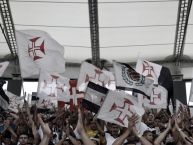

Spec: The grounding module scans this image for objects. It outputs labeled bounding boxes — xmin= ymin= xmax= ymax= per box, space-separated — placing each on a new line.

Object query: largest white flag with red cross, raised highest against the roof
xmin=16 ymin=30 xmax=65 ymax=77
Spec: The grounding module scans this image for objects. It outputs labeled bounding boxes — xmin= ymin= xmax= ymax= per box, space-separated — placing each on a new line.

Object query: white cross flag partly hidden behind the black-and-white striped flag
xmin=77 ymin=62 xmax=110 ymax=92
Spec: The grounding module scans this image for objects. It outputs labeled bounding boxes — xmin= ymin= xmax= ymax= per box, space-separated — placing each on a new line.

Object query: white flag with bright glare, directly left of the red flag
xmin=37 ymin=71 xmax=70 ymax=106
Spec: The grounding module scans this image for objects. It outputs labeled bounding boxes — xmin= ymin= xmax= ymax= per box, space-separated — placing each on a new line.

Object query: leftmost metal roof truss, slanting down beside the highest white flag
xmin=0 ymin=0 xmax=17 ymax=56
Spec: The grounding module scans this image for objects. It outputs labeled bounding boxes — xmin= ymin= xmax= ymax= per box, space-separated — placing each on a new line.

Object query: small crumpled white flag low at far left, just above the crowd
xmin=5 ymin=91 xmax=24 ymax=113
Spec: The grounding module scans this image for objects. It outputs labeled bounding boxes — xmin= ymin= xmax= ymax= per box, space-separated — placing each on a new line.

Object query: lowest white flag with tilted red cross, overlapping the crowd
xmin=97 ymin=91 xmax=144 ymax=127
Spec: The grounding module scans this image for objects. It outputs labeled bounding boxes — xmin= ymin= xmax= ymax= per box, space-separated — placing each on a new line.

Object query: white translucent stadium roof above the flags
xmin=0 ymin=0 xmax=193 ymax=66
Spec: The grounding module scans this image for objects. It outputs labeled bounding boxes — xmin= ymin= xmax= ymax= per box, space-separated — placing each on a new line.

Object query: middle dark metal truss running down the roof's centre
xmin=88 ymin=0 xmax=101 ymax=67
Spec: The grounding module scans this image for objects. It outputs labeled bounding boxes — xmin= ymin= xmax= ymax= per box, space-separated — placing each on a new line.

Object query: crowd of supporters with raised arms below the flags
xmin=0 ymin=103 xmax=193 ymax=145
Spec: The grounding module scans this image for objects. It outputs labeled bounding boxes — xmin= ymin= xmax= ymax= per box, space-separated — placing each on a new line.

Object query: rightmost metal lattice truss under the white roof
xmin=173 ymin=0 xmax=192 ymax=66
